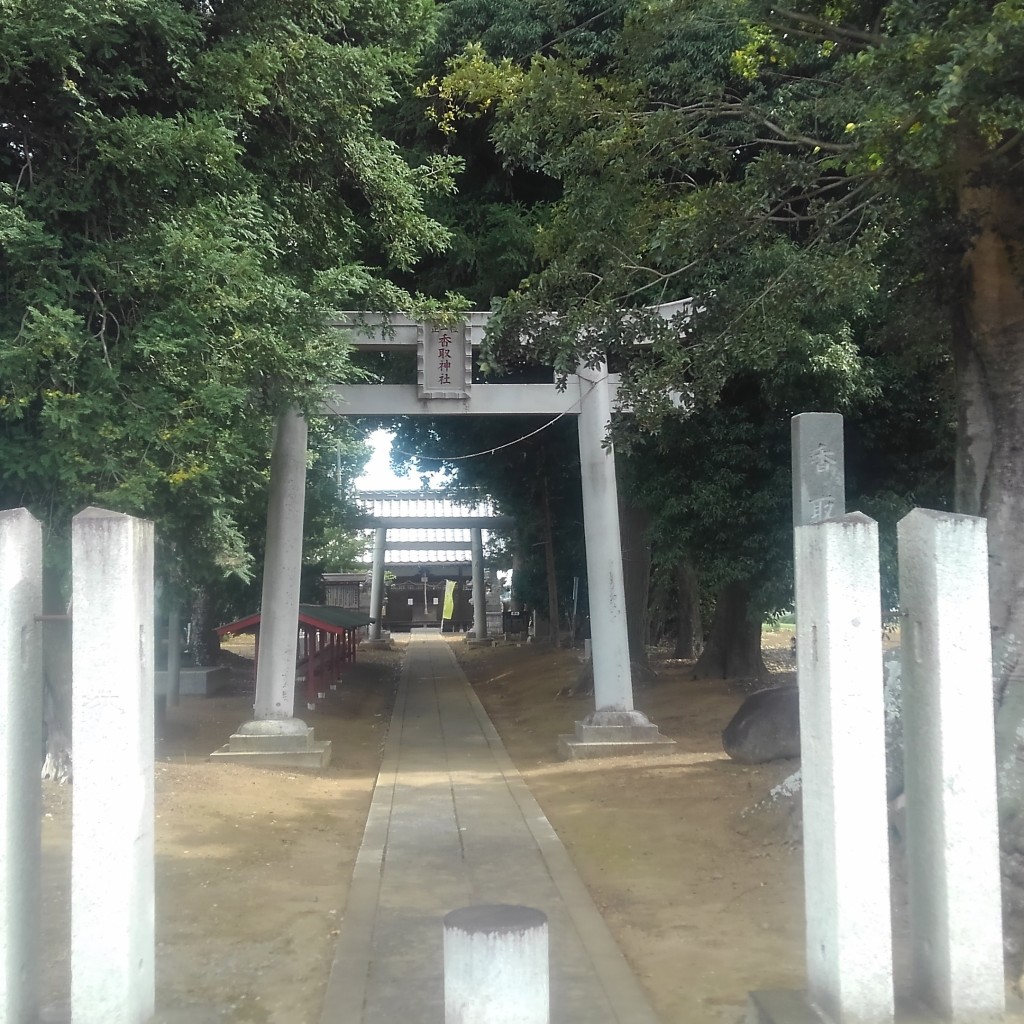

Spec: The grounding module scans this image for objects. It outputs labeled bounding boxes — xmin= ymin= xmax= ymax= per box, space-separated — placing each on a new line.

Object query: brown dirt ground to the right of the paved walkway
xmin=456 ymin=633 xmax=804 ymax=1024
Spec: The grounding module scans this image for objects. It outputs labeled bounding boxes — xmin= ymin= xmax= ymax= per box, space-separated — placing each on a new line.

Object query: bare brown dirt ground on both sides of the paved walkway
xmin=37 ymin=634 xmax=803 ymax=1024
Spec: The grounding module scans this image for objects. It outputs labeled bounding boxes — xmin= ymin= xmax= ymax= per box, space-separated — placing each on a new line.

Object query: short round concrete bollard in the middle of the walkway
xmin=444 ymin=903 xmax=551 ymax=1024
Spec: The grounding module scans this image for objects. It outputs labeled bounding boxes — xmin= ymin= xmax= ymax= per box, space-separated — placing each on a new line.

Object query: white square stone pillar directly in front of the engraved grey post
xmin=795 ymin=512 xmax=893 ymax=1024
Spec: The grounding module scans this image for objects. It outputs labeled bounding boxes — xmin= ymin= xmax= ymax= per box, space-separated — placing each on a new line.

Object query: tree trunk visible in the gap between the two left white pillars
xmin=42 ymin=569 xmax=72 ymax=782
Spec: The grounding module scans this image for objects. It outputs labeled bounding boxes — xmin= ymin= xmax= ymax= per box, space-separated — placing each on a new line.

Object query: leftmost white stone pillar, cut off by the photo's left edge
xmin=0 ymin=509 xmax=43 ymax=1024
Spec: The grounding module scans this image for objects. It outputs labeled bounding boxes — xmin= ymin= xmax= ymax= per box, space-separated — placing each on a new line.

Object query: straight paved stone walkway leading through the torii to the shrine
xmin=321 ymin=634 xmax=658 ymax=1024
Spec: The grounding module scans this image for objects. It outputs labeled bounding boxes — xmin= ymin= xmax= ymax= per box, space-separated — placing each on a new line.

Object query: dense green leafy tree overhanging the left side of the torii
xmin=0 ymin=0 xmax=452 ymax=770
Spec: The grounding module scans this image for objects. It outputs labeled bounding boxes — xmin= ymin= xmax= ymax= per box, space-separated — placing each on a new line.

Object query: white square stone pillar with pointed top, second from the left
xmin=71 ymin=508 xmax=155 ymax=1024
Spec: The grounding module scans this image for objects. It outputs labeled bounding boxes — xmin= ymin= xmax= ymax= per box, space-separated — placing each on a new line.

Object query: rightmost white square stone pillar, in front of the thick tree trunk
xmin=899 ymin=509 xmax=1006 ymax=1024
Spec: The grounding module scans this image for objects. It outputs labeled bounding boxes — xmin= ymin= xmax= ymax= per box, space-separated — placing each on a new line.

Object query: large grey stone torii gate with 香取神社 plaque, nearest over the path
xmin=232 ymin=300 xmax=691 ymax=757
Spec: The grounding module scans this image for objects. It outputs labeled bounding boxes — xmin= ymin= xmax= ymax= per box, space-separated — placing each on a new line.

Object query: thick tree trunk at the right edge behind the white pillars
xmin=954 ymin=131 xmax=1024 ymax=823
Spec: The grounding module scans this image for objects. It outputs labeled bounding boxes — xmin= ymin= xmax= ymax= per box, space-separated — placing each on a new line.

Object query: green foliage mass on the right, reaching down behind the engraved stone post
xmin=411 ymin=0 xmax=970 ymax=626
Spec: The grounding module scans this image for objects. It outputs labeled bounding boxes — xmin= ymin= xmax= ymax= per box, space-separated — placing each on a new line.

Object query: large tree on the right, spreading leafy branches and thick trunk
xmin=434 ymin=0 xmax=1024 ymax=802
